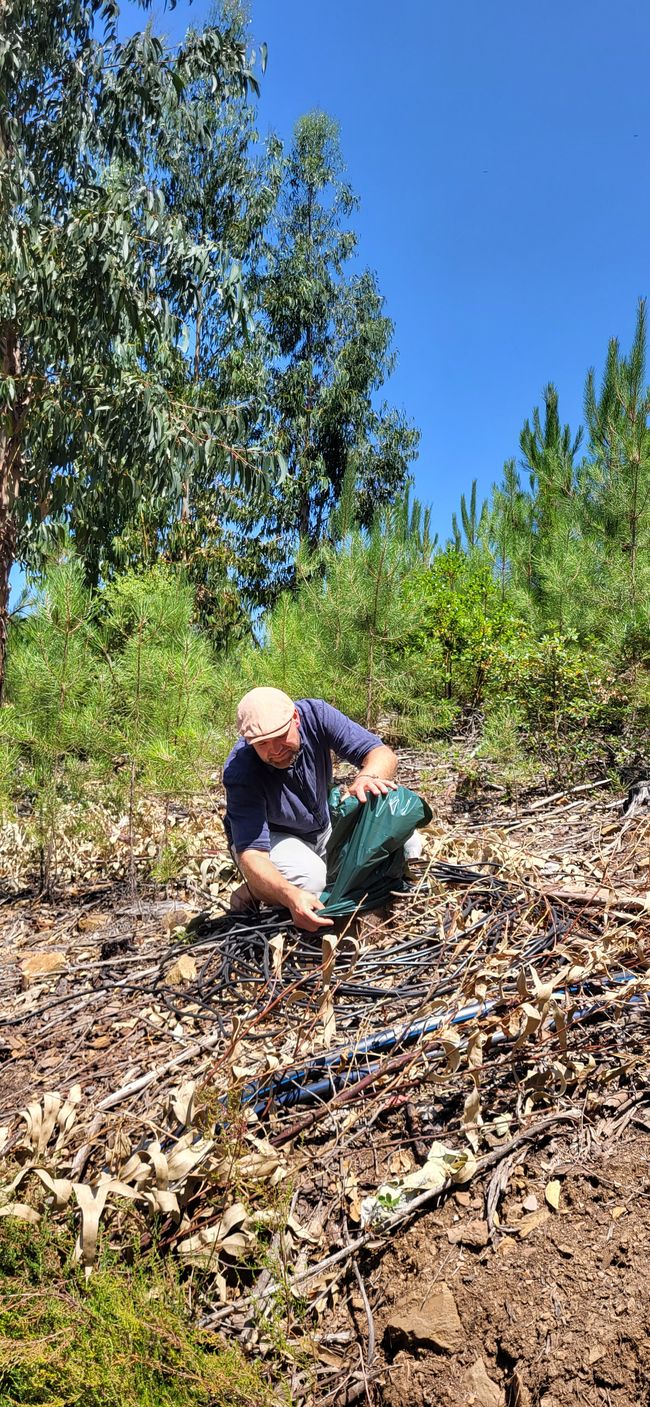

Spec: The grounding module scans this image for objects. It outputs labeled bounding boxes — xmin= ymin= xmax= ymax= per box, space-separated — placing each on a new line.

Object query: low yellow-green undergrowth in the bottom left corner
xmin=0 ymin=1218 xmax=279 ymax=1407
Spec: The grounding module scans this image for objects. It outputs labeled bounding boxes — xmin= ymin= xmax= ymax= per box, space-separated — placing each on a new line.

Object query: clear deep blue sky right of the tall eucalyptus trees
xmin=128 ymin=0 xmax=650 ymax=533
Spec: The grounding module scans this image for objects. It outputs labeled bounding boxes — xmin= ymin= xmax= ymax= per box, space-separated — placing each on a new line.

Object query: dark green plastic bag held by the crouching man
xmin=321 ymin=787 xmax=433 ymax=917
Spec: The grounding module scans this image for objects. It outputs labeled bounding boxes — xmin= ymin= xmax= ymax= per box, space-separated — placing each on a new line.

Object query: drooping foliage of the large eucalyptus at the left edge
xmin=0 ymin=0 xmax=277 ymax=692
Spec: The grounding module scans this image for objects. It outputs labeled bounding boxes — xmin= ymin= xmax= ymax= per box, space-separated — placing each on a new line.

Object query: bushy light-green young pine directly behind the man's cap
xmin=218 ymin=490 xmax=436 ymax=733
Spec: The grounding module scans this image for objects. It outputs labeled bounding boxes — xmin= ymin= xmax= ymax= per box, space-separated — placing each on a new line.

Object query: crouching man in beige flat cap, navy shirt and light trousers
xmin=224 ymin=688 xmax=397 ymax=933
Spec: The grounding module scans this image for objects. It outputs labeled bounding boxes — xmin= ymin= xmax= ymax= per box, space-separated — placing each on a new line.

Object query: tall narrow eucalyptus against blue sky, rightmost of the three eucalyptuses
xmin=262 ymin=111 xmax=419 ymax=597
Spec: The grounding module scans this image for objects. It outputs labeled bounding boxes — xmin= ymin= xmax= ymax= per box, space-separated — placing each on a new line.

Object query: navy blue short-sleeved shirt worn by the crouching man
xmin=224 ymin=699 xmax=381 ymax=854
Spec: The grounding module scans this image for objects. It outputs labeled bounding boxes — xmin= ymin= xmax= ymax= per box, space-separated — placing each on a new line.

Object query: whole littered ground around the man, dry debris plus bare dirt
xmin=0 ymin=754 xmax=650 ymax=1407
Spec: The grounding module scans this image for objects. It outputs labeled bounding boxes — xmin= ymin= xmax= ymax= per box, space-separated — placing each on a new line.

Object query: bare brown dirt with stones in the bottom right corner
xmin=334 ymin=1114 xmax=650 ymax=1407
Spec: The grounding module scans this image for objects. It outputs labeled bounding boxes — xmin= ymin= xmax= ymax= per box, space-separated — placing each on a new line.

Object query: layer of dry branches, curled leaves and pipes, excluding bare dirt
xmin=0 ymin=799 xmax=650 ymax=1401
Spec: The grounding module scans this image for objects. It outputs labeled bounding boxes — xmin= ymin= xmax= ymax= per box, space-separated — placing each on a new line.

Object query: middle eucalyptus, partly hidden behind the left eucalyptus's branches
xmin=138 ymin=0 xmax=283 ymax=644
